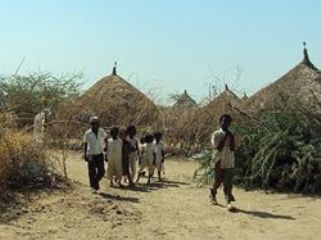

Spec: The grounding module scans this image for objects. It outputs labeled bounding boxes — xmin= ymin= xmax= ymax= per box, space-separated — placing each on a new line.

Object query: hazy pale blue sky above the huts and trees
xmin=0 ymin=0 xmax=321 ymax=103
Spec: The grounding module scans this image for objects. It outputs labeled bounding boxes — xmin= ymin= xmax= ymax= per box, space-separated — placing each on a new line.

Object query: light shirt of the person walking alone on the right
xmin=211 ymin=129 xmax=235 ymax=169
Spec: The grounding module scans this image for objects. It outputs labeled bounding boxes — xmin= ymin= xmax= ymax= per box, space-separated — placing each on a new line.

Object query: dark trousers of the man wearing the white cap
xmin=88 ymin=154 xmax=105 ymax=190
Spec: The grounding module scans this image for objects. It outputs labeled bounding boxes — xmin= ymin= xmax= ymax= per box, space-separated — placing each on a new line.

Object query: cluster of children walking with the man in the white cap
xmin=83 ymin=117 xmax=165 ymax=192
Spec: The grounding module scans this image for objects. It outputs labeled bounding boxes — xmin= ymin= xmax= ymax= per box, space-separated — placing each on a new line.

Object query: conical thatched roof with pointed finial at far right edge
xmin=244 ymin=45 xmax=321 ymax=111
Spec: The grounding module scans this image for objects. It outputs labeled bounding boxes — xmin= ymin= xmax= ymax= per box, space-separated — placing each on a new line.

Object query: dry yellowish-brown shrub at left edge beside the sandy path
xmin=0 ymin=128 xmax=53 ymax=196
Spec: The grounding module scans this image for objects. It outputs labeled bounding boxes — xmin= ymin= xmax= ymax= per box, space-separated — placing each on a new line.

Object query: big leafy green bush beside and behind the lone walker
xmin=195 ymin=108 xmax=321 ymax=193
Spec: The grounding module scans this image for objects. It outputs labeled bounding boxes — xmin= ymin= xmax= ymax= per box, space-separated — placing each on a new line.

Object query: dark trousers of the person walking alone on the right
xmin=211 ymin=168 xmax=235 ymax=203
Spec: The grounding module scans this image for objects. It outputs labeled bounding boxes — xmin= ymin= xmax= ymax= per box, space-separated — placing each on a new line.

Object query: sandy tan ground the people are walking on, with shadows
xmin=0 ymin=153 xmax=321 ymax=240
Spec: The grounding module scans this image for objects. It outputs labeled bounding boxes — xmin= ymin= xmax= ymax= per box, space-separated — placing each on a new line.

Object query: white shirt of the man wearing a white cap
xmin=83 ymin=128 xmax=107 ymax=155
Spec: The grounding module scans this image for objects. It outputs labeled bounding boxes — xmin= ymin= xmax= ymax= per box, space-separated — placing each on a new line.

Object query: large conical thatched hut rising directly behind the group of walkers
xmin=58 ymin=63 xmax=160 ymax=131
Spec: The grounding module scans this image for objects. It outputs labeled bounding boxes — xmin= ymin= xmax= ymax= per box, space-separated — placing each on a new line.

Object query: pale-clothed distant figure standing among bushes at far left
xmin=33 ymin=108 xmax=51 ymax=144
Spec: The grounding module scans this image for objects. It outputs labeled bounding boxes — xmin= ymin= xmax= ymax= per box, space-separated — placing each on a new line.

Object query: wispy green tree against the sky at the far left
xmin=0 ymin=73 xmax=83 ymax=126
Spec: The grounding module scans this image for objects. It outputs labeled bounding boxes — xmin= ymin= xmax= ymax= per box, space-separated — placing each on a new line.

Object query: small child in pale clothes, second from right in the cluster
xmin=136 ymin=134 xmax=156 ymax=184
